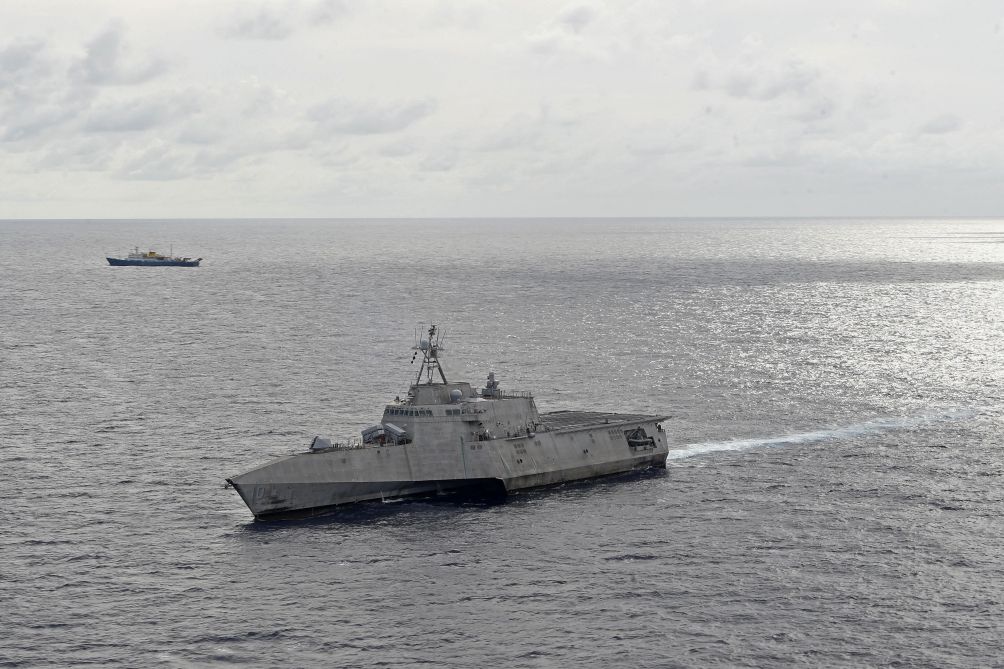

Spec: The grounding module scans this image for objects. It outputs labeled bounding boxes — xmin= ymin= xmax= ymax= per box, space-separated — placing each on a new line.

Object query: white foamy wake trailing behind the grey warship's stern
xmin=669 ymin=409 xmax=979 ymax=460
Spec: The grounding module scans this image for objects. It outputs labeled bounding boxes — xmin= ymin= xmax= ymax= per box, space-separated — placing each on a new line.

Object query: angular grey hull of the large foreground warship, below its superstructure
xmin=227 ymin=412 xmax=669 ymax=520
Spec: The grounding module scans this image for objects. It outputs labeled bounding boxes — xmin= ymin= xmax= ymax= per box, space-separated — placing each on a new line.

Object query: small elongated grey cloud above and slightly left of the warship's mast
xmin=309 ymin=97 xmax=436 ymax=135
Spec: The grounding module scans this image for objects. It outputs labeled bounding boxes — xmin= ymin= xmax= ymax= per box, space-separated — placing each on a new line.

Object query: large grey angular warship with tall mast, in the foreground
xmin=227 ymin=325 xmax=669 ymax=518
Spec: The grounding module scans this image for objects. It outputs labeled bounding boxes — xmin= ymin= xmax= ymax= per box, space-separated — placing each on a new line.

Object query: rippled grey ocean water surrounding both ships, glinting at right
xmin=0 ymin=219 xmax=1004 ymax=667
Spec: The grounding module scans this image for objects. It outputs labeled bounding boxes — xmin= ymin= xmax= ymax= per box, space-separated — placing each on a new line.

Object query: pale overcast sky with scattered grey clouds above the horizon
xmin=0 ymin=0 xmax=1004 ymax=218
